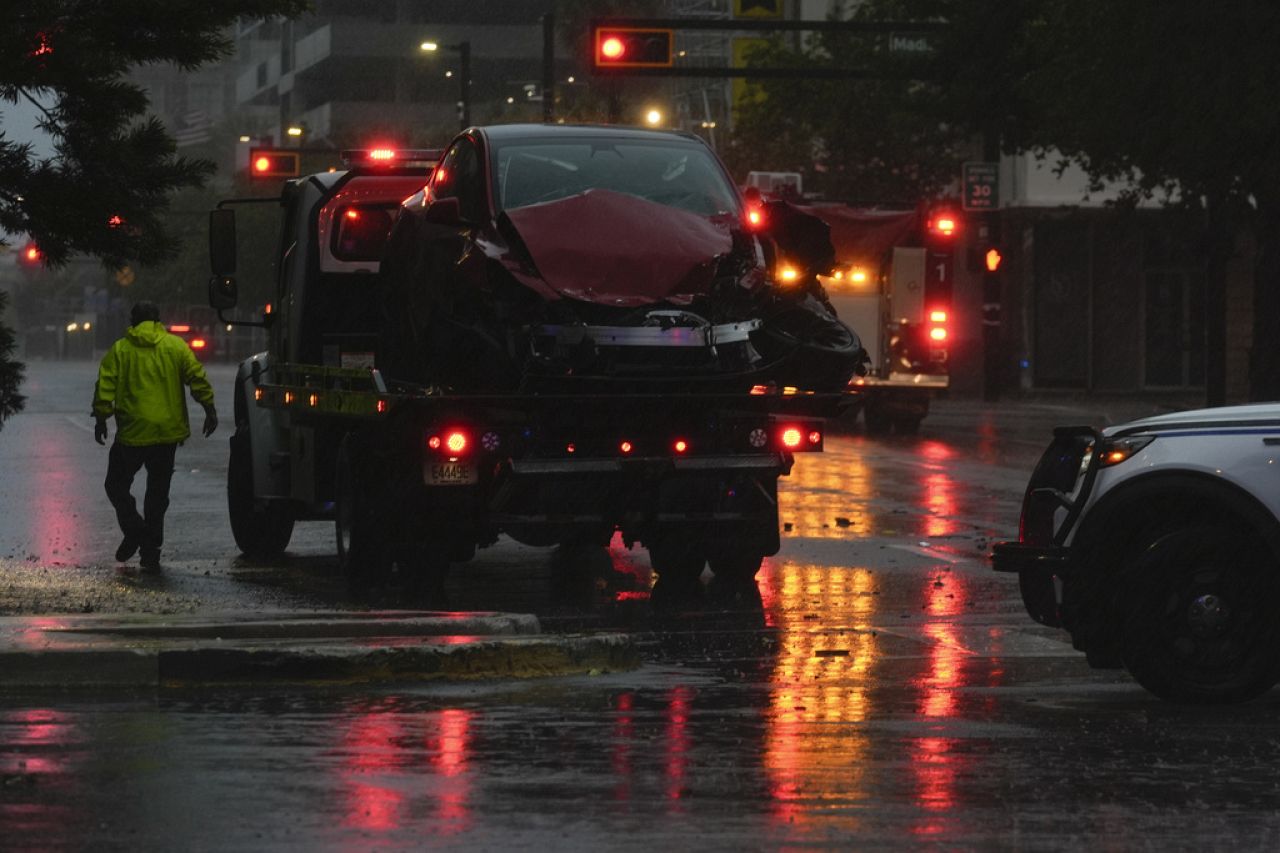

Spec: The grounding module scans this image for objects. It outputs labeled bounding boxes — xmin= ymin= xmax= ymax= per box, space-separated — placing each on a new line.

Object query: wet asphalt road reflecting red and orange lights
xmin=0 ymin=364 xmax=1280 ymax=850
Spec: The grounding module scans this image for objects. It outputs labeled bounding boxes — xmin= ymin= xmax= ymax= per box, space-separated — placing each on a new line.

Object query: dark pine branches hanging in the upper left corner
xmin=0 ymin=0 xmax=307 ymax=268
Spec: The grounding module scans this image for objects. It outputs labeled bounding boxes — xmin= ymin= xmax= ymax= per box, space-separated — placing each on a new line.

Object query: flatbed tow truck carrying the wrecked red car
xmin=209 ymin=137 xmax=847 ymax=602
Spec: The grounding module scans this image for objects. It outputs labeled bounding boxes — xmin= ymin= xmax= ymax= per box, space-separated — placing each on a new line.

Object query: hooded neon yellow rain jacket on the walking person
xmin=93 ymin=320 xmax=214 ymax=447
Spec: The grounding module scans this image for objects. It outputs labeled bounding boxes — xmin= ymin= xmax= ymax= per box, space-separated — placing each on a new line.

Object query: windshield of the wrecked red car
xmin=493 ymin=140 xmax=739 ymax=216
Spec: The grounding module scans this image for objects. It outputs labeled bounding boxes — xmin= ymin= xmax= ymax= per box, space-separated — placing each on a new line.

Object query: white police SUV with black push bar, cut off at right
xmin=992 ymin=403 xmax=1280 ymax=703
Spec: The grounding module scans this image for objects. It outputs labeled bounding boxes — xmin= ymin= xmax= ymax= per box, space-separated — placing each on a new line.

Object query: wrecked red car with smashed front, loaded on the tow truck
xmin=381 ymin=126 xmax=867 ymax=393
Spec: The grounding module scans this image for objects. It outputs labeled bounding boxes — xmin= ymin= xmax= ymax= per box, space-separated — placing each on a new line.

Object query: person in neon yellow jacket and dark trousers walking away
xmin=93 ymin=302 xmax=218 ymax=571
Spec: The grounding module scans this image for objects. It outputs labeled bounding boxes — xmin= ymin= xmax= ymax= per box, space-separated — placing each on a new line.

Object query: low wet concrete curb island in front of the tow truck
xmin=0 ymin=611 xmax=639 ymax=688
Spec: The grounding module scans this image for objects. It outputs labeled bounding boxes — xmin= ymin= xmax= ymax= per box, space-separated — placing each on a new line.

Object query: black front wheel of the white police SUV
xmin=1120 ymin=523 xmax=1280 ymax=704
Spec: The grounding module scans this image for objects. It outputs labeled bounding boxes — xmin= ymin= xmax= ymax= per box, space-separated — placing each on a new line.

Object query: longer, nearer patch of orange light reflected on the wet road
xmin=764 ymin=562 xmax=879 ymax=830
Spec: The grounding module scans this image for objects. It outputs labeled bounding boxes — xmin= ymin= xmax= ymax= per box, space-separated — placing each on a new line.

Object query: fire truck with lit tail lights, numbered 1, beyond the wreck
xmin=803 ymin=204 xmax=960 ymax=434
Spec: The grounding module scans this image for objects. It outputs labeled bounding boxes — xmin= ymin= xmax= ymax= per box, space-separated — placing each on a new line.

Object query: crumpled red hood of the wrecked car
xmin=507 ymin=190 xmax=732 ymax=307
